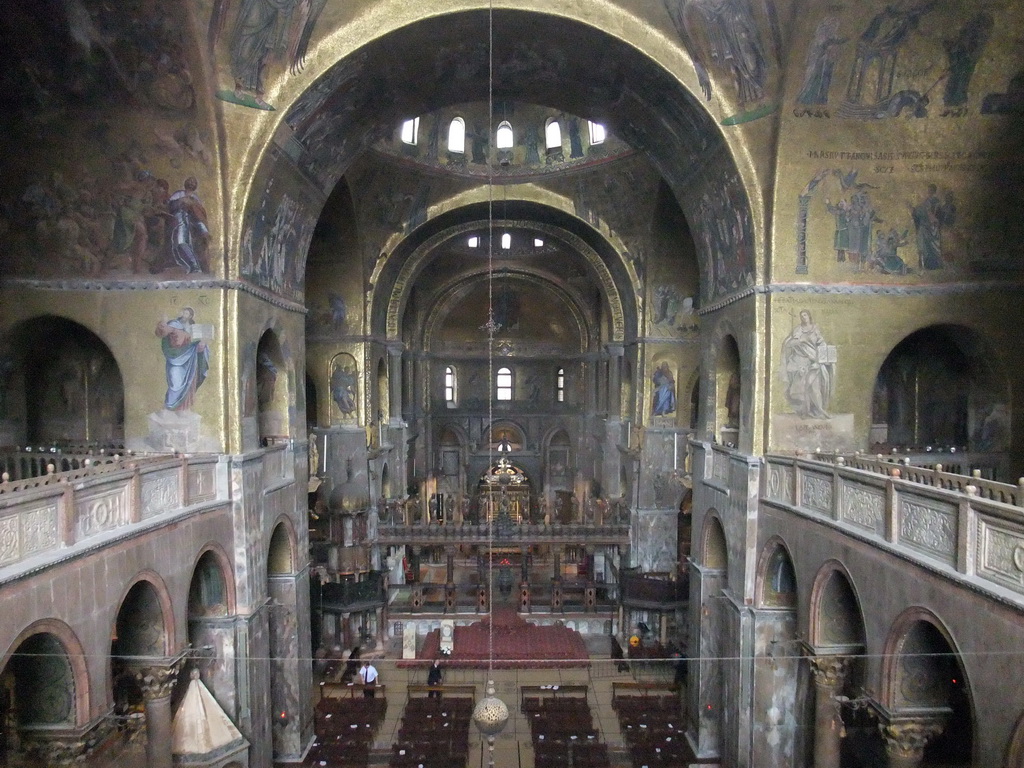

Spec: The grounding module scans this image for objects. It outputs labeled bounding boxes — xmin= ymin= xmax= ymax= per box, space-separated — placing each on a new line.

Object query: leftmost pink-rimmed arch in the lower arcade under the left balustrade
xmin=0 ymin=618 xmax=91 ymax=726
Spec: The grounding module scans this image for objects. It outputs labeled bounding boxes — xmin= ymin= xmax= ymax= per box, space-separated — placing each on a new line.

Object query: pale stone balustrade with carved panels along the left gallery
xmin=0 ymin=454 xmax=227 ymax=578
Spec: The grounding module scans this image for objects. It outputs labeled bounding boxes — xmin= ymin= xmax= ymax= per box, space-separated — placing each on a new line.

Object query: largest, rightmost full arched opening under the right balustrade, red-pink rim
xmin=882 ymin=608 xmax=975 ymax=768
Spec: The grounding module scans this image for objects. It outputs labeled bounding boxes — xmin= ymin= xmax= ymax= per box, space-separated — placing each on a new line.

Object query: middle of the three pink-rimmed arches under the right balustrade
xmin=808 ymin=560 xmax=865 ymax=651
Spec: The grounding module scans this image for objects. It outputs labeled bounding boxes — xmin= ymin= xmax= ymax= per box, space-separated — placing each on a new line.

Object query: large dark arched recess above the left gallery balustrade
xmin=0 ymin=315 xmax=125 ymax=444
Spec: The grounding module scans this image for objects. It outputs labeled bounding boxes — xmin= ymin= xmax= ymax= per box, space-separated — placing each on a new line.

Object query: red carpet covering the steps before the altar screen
xmin=399 ymin=606 xmax=590 ymax=669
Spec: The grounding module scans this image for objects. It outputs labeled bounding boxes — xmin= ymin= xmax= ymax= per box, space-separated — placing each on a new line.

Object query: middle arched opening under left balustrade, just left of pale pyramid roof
xmin=111 ymin=579 xmax=173 ymax=716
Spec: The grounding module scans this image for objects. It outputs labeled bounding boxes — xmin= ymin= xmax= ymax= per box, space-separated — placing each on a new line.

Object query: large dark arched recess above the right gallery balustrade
xmin=871 ymin=325 xmax=1012 ymax=462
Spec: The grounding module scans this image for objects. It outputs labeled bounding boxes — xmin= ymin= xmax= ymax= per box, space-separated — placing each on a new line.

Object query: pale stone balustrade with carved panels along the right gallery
xmin=765 ymin=447 xmax=1024 ymax=605
